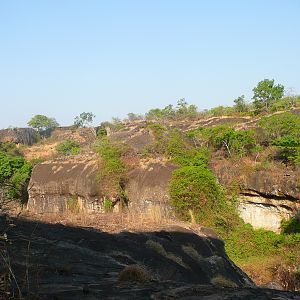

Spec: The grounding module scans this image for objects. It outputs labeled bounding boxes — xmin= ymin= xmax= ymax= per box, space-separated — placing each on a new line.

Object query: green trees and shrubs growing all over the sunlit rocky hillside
xmin=0 ymin=79 xmax=300 ymax=289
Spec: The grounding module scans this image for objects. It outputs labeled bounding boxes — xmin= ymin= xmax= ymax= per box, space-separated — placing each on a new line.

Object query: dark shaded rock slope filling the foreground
xmin=0 ymin=217 xmax=300 ymax=300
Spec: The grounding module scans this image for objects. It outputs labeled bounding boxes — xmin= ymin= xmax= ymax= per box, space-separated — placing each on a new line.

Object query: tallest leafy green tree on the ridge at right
xmin=252 ymin=79 xmax=284 ymax=112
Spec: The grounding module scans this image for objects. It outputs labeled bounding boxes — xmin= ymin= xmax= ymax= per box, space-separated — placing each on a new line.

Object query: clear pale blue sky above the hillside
xmin=0 ymin=0 xmax=300 ymax=128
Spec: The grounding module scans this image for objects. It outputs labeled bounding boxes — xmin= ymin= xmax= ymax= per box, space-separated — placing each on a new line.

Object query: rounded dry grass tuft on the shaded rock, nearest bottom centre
xmin=119 ymin=264 xmax=152 ymax=283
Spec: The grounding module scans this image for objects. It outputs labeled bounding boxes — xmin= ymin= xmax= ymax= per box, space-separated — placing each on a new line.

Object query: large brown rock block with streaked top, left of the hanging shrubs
xmin=27 ymin=153 xmax=102 ymax=213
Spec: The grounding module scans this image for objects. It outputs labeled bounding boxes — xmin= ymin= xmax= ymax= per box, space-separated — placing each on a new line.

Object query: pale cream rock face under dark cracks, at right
xmin=238 ymin=195 xmax=297 ymax=233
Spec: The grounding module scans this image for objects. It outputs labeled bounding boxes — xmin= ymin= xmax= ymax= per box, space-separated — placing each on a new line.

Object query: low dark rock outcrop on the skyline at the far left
xmin=0 ymin=128 xmax=38 ymax=145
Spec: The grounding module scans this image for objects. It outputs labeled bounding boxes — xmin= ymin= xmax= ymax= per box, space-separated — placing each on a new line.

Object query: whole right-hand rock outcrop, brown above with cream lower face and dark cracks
xmin=212 ymin=161 xmax=300 ymax=232
